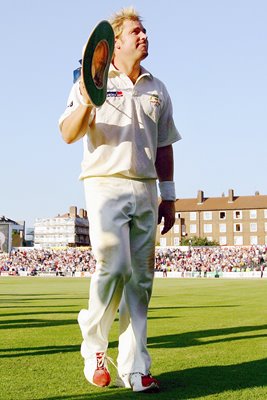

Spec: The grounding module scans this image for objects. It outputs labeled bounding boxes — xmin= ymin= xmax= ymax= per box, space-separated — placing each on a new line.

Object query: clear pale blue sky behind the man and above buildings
xmin=0 ymin=0 xmax=267 ymax=227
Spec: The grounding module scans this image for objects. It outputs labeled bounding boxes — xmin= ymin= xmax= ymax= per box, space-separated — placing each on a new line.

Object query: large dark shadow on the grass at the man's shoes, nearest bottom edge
xmin=35 ymin=358 xmax=267 ymax=400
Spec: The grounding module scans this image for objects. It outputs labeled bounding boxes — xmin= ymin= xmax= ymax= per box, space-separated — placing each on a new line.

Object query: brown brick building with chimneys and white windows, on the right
xmin=157 ymin=189 xmax=267 ymax=247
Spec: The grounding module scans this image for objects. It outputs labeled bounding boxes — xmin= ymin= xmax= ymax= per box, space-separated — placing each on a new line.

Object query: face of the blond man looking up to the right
xmin=116 ymin=20 xmax=148 ymax=61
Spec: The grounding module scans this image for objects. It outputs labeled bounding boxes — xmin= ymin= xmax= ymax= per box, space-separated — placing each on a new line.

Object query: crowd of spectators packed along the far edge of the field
xmin=0 ymin=246 xmax=267 ymax=276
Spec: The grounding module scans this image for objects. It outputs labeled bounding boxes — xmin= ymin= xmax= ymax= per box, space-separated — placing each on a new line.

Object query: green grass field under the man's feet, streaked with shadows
xmin=0 ymin=277 xmax=267 ymax=400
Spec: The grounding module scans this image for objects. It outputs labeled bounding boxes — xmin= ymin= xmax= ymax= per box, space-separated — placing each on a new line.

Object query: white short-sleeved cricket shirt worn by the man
xmin=59 ymin=66 xmax=181 ymax=179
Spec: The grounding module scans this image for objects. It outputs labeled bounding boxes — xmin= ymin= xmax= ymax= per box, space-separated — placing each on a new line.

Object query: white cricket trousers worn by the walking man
xmin=78 ymin=177 xmax=158 ymax=375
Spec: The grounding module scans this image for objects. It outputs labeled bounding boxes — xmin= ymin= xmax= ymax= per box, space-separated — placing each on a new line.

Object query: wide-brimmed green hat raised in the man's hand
xmin=82 ymin=20 xmax=115 ymax=107
